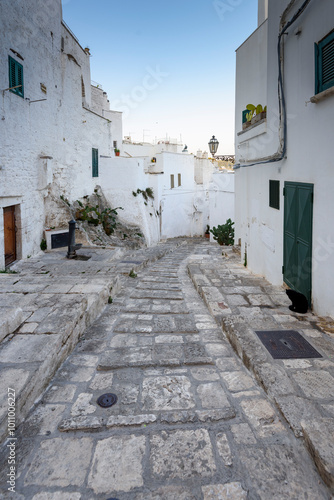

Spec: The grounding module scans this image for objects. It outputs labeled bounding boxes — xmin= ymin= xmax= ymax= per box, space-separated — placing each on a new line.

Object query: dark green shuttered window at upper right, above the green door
xmin=315 ymin=31 xmax=334 ymax=94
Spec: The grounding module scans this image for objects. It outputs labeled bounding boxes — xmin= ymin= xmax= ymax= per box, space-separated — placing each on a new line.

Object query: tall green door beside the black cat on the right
xmin=283 ymin=182 xmax=313 ymax=304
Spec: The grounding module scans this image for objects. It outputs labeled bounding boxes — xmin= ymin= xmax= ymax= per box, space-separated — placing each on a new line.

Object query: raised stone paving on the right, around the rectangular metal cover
xmin=188 ymin=247 xmax=334 ymax=490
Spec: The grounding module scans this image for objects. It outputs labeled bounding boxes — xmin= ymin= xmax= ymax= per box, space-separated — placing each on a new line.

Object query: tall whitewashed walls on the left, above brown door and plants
xmin=0 ymin=0 xmax=122 ymax=268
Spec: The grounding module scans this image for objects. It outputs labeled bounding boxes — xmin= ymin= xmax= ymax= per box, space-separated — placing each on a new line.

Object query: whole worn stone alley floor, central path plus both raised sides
xmin=0 ymin=240 xmax=334 ymax=500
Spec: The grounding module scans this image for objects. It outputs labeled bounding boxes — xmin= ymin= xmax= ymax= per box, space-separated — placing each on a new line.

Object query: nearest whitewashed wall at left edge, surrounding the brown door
xmin=0 ymin=0 xmax=61 ymax=268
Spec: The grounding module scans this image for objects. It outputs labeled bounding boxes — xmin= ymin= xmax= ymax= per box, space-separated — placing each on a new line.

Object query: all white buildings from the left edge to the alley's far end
xmin=0 ymin=0 xmax=235 ymax=269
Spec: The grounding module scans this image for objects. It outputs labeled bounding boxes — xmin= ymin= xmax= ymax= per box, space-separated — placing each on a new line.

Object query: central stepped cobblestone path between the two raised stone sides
xmin=0 ymin=241 xmax=331 ymax=500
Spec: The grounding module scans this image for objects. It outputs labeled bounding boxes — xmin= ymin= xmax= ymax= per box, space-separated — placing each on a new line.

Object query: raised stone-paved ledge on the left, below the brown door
xmin=0 ymin=239 xmax=188 ymax=441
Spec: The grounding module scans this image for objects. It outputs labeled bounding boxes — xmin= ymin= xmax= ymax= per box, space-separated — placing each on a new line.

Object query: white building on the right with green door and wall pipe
xmin=235 ymin=0 xmax=334 ymax=316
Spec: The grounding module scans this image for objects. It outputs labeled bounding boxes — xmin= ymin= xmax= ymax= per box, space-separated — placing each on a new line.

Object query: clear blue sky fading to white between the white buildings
xmin=63 ymin=0 xmax=257 ymax=154
